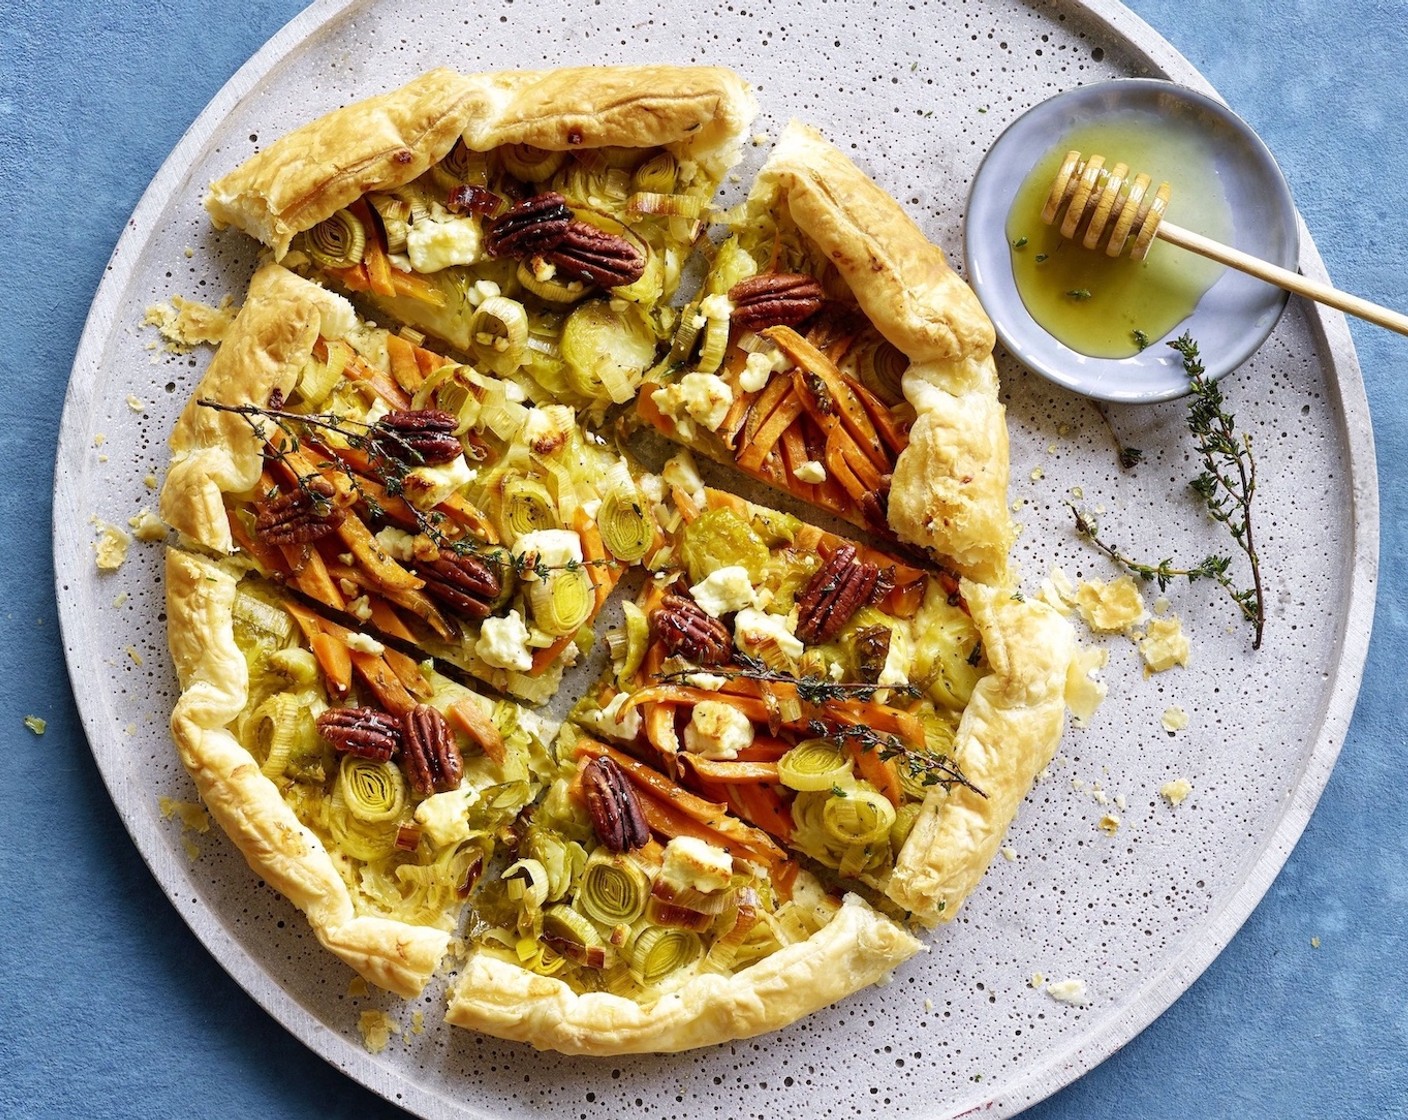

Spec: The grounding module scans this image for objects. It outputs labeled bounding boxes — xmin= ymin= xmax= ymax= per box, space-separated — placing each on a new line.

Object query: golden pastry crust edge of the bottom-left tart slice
xmin=166 ymin=548 xmax=449 ymax=999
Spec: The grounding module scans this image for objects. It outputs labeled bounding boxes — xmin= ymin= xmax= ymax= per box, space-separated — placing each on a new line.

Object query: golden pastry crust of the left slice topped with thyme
xmin=161 ymin=265 xmax=355 ymax=552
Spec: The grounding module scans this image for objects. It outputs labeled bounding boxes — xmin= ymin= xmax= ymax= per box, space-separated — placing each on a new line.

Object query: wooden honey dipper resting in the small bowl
xmin=1042 ymin=151 xmax=1408 ymax=334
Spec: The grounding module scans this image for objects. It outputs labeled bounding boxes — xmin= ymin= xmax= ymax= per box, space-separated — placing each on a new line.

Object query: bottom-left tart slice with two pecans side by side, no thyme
xmin=166 ymin=549 xmax=552 ymax=997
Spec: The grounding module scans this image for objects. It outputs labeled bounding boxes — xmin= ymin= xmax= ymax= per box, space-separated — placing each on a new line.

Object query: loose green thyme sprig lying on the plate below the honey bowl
xmin=1066 ymin=334 xmax=1266 ymax=649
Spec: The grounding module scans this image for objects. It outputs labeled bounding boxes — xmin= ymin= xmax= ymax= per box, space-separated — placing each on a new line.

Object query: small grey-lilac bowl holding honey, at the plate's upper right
xmin=964 ymin=77 xmax=1300 ymax=404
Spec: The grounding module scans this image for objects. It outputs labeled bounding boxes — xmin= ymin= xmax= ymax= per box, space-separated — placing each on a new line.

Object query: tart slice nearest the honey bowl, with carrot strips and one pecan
xmin=636 ymin=124 xmax=1012 ymax=583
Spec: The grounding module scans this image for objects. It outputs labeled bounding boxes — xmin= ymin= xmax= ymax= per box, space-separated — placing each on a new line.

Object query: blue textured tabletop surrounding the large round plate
xmin=0 ymin=0 xmax=1408 ymax=1120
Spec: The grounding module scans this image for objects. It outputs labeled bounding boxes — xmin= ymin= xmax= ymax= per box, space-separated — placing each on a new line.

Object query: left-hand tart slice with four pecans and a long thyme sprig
xmin=162 ymin=265 xmax=658 ymax=700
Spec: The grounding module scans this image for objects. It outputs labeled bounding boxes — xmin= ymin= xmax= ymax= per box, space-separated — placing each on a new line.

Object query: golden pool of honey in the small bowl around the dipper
xmin=1007 ymin=113 xmax=1232 ymax=358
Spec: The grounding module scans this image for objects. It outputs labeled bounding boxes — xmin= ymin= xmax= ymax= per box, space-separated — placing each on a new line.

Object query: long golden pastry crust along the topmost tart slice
xmin=206 ymin=65 xmax=756 ymax=258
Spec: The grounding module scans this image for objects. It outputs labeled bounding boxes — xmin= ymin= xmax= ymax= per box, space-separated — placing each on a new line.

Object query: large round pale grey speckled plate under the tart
xmin=54 ymin=0 xmax=1377 ymax=1120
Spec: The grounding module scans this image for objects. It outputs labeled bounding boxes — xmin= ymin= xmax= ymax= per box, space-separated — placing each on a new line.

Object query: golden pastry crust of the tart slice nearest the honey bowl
xmin=750 ymin=121 xmax=1014 ymax=583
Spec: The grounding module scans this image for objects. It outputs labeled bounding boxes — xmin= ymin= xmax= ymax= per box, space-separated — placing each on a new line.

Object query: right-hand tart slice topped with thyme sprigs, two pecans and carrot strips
xmin=576 ymin=490 xmax=1080 ymax=924
